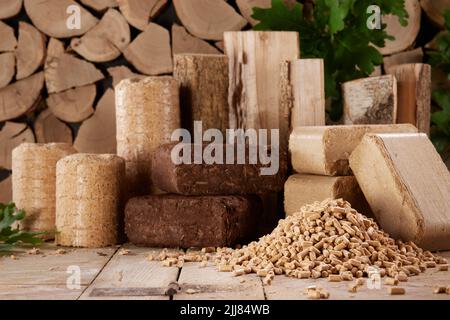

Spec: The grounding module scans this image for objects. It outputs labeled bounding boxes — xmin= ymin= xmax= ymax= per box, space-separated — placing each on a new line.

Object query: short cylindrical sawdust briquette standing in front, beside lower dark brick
xmin=56 ymin=154 xmax=125 ymax=248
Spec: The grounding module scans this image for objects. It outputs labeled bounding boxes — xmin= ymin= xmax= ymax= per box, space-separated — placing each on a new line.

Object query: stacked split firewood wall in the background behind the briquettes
xmin=0 ymin=0 xmax=450 ymax=201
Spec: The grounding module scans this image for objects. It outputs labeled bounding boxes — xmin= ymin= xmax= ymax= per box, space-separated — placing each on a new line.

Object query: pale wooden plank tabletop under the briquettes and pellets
xmin=0 ymin=245 xmax=450 ymax=300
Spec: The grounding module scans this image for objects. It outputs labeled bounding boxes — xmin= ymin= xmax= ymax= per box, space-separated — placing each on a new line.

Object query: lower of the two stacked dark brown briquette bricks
xmin=125 ymin=195 xmax=262 ymax=248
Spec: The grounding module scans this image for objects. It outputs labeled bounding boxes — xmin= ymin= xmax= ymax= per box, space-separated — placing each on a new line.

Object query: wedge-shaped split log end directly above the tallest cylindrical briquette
xmin=123 ymin=23 xmax=173 ymax=75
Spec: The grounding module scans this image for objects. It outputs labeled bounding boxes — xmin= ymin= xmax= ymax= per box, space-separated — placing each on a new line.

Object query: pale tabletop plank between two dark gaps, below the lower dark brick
xmin=80 ymin=245 xmax=179 ymax=300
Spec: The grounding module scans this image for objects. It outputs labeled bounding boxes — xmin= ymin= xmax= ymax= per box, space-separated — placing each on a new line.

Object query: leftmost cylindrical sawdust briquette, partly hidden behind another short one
xmin=12 ymin=143 xmax=76 ymax=234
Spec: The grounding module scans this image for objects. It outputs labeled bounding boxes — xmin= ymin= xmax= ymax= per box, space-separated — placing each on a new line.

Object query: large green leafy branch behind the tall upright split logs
xmin=252 ymin=0 xmax=408 ymax=120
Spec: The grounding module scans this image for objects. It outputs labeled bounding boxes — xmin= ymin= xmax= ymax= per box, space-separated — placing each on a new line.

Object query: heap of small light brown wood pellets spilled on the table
xmin=159 ymin=199 xmax=448 ymax=285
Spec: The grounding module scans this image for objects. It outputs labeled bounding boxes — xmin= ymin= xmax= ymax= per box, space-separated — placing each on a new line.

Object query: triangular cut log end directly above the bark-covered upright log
xmin=172 ymin=24 xmax=221 ymax=55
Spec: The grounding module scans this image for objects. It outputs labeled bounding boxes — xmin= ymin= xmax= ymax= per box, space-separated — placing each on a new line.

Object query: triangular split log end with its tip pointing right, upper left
xmin=45 ymin=48 xmax=104 ymax=93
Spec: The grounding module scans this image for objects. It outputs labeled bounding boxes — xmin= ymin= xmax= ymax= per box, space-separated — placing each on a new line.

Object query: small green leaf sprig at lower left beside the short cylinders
xmin=0 ymin=203 xmax=43 ymax=252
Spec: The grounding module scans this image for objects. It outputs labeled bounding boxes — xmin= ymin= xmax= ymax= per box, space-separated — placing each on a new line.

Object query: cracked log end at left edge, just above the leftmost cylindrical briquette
xmin=0 ymin=121 xmax=35 ymax=170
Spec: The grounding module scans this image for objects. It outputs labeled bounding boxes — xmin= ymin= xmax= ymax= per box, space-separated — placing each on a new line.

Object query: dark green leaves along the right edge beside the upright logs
xmin=428 ymin=10 xmax=450 ymax=155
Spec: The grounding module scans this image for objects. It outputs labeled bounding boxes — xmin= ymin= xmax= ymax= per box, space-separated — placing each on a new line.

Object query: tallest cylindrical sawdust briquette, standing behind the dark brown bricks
xmin=116 ymin=76 xmax=180 ymax=196
